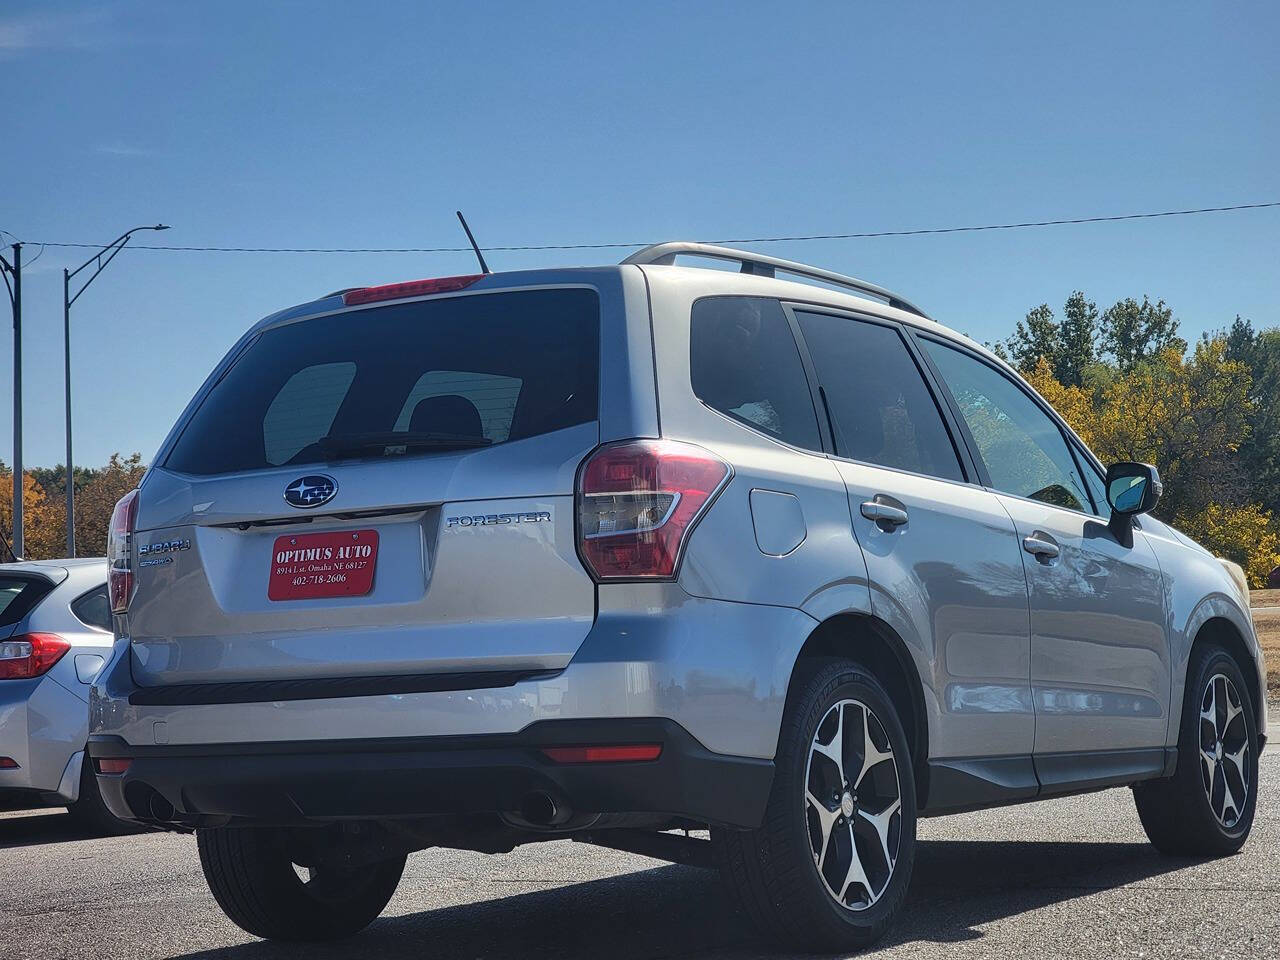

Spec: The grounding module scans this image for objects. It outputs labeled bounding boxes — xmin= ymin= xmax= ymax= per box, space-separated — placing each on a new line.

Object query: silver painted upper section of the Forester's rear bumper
xmin=90 ymin=584 xmax=817 ymax=759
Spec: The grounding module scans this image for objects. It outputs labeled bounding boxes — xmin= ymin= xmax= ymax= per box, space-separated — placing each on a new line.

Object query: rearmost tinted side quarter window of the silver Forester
xmin=689 ymin=297 xmax=822 ymax=449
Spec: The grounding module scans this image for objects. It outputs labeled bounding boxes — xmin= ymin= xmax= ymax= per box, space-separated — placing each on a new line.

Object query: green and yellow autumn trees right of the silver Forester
xmin=988 ymin=291 xmax=1280 ymax=586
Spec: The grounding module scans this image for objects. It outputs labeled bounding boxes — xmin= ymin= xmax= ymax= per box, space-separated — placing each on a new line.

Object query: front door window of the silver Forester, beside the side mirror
xmin=924 ymin=339 xmax=1092 ymax=513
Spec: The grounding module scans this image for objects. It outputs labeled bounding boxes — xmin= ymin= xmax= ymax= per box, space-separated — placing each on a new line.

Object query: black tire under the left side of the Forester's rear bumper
xmin=196 ymin=827 xmax=404 ymax=941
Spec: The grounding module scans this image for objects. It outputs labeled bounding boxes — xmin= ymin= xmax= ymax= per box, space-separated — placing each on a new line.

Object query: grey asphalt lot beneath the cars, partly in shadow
xmin=0 ymin=723 xmax=1280 ymax=960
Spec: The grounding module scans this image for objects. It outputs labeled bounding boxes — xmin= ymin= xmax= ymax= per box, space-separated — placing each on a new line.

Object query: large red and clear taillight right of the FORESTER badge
xmin=577 ymin=440 xmax=730 ymax=580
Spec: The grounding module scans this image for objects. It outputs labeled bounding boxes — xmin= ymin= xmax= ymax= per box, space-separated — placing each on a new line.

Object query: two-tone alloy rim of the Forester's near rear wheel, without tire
xmin=804 ymin=700 xmax=902 ymax=910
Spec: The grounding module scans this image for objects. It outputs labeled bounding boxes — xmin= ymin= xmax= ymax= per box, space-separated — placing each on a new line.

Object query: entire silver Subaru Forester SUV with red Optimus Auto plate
xmin=90 ymin=243 xmax=1266 ymax=950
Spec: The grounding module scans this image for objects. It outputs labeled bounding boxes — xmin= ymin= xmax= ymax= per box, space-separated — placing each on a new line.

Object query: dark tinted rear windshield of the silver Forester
xmin=165 ymin=289 xmax=600 ymax=475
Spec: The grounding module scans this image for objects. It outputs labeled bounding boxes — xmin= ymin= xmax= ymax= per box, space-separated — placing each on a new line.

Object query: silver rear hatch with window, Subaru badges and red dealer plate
xmin=127 ymin=287 xmax=600 ymax=686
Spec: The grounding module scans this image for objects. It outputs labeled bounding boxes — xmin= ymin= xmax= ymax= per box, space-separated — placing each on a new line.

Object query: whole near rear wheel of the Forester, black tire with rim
xmin=713 ymin=660 xmax=915 ymax=952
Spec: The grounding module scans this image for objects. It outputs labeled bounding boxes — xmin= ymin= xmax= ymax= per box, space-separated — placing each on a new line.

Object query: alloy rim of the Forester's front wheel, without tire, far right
xmin=1199 ymin=673 xmax=1253 ymax=829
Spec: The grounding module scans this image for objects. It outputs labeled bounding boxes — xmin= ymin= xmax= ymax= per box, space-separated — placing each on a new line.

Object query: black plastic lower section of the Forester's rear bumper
xmin=90 ymin=718 xmax=773 ymax=827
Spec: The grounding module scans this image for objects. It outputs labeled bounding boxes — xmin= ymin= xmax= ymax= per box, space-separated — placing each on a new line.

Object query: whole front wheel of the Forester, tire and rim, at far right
xmin=1133 ymin=644 xmax=1258 ymax=856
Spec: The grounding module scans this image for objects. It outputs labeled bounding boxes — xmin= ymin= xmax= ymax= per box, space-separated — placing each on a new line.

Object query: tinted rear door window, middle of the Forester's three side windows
xmin=796 ymin=314 xmax=964 ymax=480
